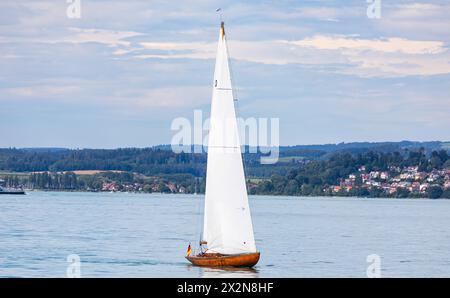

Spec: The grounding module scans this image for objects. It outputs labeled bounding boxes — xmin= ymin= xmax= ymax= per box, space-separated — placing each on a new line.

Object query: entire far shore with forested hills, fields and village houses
xmin=0 ymin=141 xmax=450 ymax=199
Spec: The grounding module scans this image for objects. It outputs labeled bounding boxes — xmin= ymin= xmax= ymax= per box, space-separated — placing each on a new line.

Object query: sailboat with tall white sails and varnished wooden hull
xmin=186 ymin=22 xmax=260 ymax=267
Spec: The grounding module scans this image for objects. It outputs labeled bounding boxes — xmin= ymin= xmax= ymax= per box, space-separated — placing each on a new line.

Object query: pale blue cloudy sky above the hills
xmin=0 ymin=0 xmax=450 ymax=148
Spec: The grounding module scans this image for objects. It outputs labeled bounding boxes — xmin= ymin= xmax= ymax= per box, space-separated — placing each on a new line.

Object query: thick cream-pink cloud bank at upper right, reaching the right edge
xmin=284 ymin=36 xmax=450 ymax=77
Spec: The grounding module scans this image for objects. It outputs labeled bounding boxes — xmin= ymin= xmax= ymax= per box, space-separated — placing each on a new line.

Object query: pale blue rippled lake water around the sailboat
xmin=0 ymin=192 xmax=450 ymax=277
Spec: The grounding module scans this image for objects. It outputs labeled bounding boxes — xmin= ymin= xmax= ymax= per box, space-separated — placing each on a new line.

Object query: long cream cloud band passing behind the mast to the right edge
xmin=134 ymin=35 xmax=450 ymax=77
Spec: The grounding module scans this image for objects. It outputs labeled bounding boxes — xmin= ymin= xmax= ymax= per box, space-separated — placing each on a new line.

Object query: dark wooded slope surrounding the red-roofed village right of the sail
xmin=249 ymin=150 xmax=450 ymax=198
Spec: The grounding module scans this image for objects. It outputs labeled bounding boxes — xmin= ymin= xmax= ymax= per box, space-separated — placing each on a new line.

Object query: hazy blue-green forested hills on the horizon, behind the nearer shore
xmin=0 ymin=141 xmax=450 ymax=177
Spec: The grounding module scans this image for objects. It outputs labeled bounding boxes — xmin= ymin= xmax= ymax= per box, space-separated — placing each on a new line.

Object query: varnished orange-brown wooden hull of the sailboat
xmin=186 ymin=252 xmax=260 ymax=267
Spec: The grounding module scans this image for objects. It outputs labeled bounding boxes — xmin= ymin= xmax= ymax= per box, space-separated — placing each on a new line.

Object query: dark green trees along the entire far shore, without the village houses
xmin=0 ymin=148 xmax=450 ymax=197
